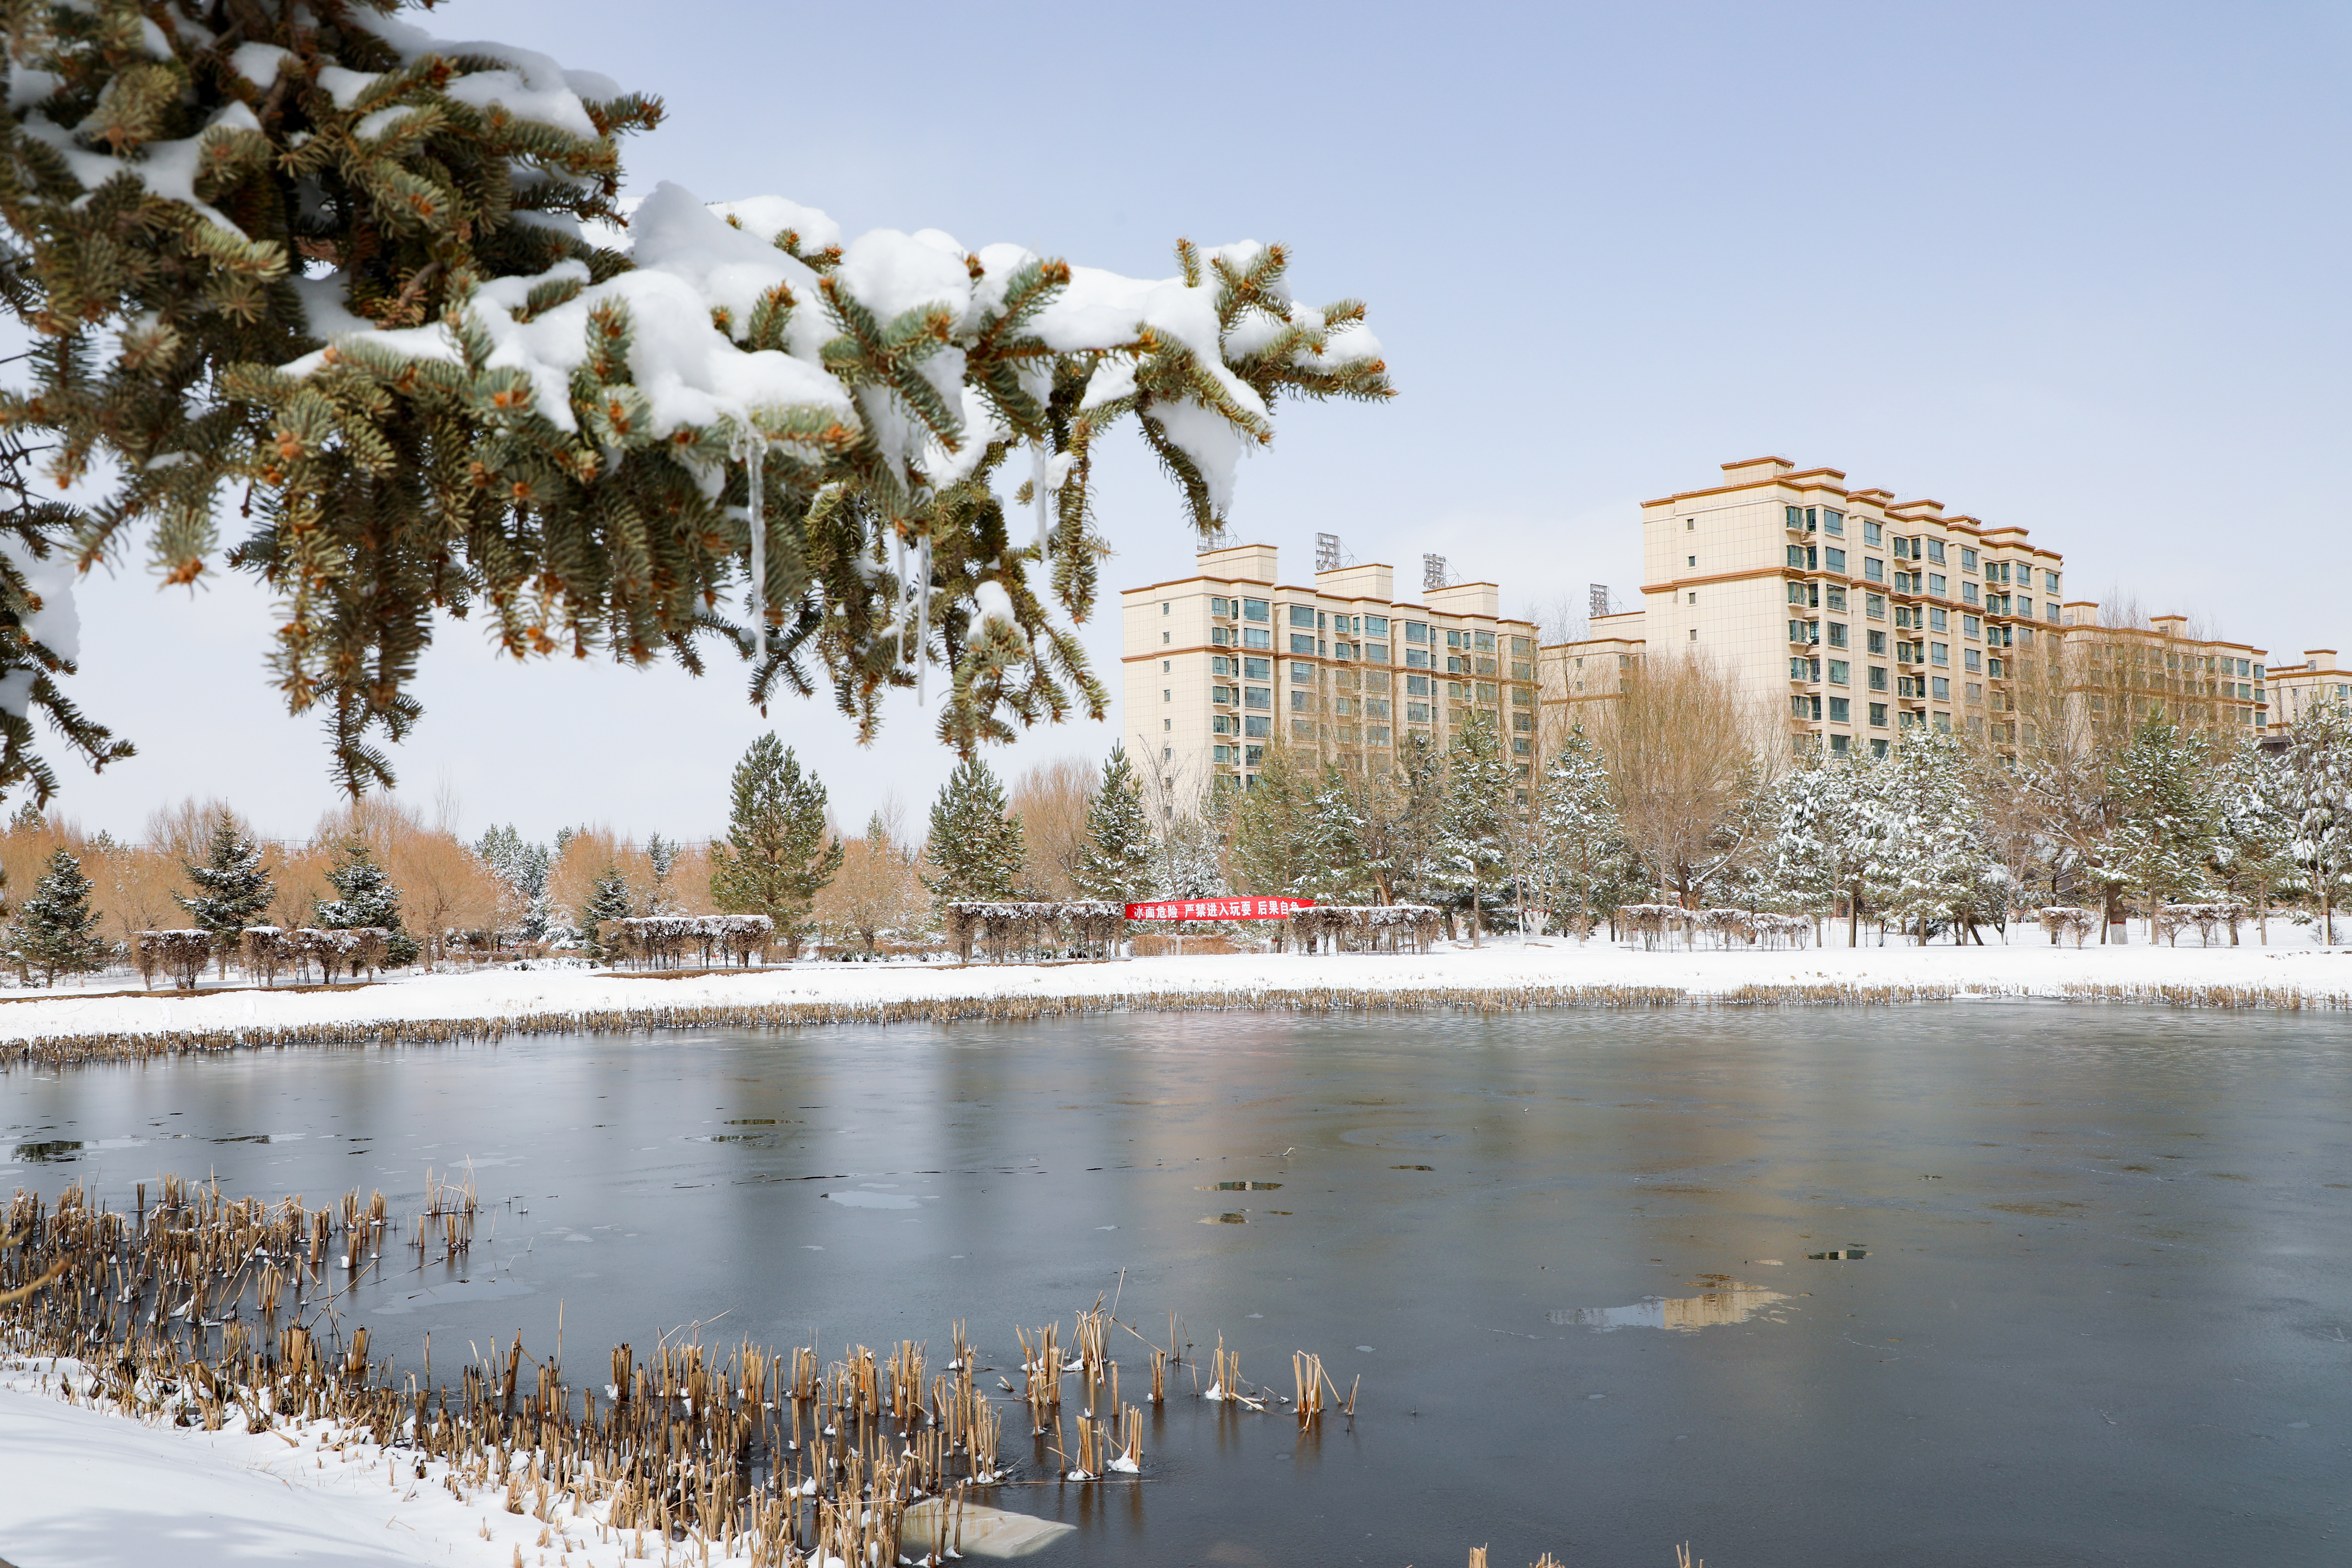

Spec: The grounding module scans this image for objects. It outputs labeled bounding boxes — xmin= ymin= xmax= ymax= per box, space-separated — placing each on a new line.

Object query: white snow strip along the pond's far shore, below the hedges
xmin=0 ymin=931 xmax=2352 ymax=1039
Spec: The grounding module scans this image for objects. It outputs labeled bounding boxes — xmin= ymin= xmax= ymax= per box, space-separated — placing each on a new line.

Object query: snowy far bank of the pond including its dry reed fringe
xmin=0 ymin=940 xmax=2352 ymax=1049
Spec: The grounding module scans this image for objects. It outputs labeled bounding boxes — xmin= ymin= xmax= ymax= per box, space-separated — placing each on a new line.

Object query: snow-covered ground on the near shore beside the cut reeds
xmin=0 ymin=1359 xmax=635 ymax=1568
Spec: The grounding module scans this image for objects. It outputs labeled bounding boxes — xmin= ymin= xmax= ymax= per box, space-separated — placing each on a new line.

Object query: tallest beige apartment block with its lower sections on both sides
xmin=1541 ymin=458 xmax=2265 ymax=755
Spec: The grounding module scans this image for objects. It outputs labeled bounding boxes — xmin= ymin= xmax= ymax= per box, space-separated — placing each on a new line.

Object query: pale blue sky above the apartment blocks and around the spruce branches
xmin=41 ymin=0 xmax=2352 ymax=834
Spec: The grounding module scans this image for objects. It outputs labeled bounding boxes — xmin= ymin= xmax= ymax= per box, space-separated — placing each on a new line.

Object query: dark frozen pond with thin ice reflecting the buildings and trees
xmin=0 ymin=1004 xmax=2352 ymax=1568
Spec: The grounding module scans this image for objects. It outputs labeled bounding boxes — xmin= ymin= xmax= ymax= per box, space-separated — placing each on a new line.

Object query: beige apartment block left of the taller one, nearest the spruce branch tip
xmin=1120 ymin=545 xmax=1538 ymax=792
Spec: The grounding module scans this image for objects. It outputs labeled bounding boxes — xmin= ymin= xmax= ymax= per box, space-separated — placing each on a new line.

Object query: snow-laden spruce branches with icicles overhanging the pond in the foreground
xmin=0 ymin=0 xmax=1390 ymax=792
